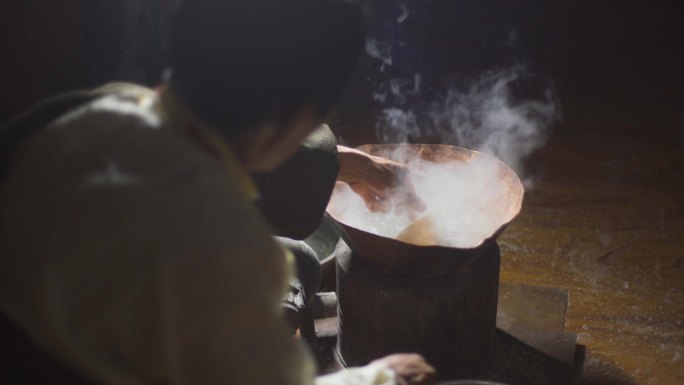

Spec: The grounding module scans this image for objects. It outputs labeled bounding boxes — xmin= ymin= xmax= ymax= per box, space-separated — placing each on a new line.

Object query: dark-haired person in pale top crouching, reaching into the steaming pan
xmin=0 ymin=0 xmax=434 ymax=385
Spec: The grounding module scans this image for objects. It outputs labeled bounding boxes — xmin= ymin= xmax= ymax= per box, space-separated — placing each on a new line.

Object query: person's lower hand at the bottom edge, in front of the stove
xmin=371 ymin=353 xmax=437 ymax=385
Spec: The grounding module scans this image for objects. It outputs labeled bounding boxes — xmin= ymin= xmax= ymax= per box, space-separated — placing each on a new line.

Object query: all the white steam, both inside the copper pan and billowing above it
xmin=332 ymin=43 xmax=560 ymax=248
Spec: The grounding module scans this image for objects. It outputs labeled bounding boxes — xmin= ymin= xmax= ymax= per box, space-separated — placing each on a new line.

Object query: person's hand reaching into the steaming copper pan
xmin=337 ymin=146 xmax=425 ymax=218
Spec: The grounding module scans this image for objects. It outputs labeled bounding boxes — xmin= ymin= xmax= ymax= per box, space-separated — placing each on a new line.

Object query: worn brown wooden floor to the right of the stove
xmin=499 ymin=87 xmax=684 ymax=385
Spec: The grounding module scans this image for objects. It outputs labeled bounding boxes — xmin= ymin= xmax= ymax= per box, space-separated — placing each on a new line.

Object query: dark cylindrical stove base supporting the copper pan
xmin=337 ymin=243 xmax=500 ymax=379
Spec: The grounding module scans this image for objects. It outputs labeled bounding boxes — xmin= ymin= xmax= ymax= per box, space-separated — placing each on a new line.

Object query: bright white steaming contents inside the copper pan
xmin=331 ymin=157 xmax=505 ymax=248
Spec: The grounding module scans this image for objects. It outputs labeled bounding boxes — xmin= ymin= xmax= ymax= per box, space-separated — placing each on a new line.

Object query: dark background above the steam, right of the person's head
xmin=336 ymin=0 xmax=684 ymax=144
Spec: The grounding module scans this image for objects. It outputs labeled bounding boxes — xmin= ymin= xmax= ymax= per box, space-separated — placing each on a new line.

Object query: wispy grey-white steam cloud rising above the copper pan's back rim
xmin=377 ymin=67 xmax=560 ymax=178
